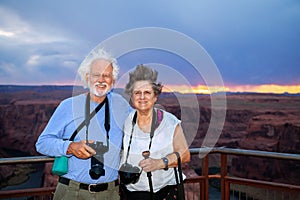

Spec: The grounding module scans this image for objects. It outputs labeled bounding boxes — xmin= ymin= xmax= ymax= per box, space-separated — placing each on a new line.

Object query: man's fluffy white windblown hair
xmin=77 ymin=48 xmax=120 ymax=88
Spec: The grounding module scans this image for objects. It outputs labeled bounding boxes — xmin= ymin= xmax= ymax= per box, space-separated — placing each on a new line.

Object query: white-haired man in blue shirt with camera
xmin=36 ymin=49 xmax=131 ymax=200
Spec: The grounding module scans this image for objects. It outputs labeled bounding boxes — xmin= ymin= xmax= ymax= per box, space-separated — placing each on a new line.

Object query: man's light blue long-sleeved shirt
xmin=36 ymin=92 xmax=132 ymax=184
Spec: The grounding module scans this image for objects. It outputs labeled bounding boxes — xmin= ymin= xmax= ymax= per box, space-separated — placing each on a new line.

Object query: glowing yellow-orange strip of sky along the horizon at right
xmin=163 ymin=84 xmax=300 ymax=94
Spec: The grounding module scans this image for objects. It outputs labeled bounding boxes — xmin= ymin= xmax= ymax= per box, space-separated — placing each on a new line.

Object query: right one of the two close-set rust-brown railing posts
xmin=221 ymin=153 xmax=230 ymax=200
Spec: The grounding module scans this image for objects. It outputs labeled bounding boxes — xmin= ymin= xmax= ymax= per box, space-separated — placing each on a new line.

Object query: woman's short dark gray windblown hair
xmin=125 ymin=64 xmax=163 ymax=96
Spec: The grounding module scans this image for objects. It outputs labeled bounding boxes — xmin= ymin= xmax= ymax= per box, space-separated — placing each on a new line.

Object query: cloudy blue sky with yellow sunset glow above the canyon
xmin=0 ymin=0 xmax=300 ymax=93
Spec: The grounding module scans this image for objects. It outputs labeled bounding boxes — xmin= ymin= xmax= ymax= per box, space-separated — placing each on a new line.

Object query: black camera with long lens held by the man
xmin=89 ymin=142 xmax=108 ymax=179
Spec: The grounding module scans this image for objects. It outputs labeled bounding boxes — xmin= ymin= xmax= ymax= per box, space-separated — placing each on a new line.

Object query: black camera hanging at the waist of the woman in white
xmin=119 ymin=163 xmax=141 ymax=185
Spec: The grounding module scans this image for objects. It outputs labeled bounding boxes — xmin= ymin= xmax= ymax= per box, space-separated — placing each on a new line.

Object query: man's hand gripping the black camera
xmin=67 ymin=140 xmax=96 ymax=159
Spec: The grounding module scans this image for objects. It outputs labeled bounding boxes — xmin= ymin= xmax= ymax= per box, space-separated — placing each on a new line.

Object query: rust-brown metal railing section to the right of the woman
xmin=190 ymin=148 xmax=300 ymax=200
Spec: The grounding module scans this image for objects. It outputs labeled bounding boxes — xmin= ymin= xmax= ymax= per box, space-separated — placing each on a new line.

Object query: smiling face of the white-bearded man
xmin=86 ymin=60 xmax=114 ymax=97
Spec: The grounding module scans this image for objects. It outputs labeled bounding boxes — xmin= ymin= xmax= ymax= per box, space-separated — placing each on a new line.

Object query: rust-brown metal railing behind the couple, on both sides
xmin=0 ymin=148 xmax=300 ymax=200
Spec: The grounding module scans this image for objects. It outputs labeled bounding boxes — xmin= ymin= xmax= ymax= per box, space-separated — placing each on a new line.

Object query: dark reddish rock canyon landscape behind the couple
xmin=0 ymin=86 xmax=300 ymax=187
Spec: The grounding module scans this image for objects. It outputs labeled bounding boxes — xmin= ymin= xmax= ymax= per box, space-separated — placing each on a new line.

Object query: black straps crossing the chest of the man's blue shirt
xmin=69 ymin=93 xmax=110 ymax=145
